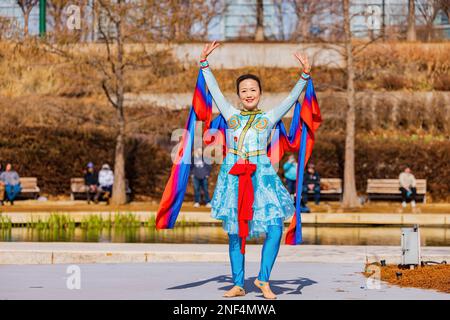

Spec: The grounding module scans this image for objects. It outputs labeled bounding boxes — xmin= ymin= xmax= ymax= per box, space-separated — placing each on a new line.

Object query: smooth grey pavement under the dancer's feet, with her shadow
xmin=0 ymin=262 xmax=450 ymax=301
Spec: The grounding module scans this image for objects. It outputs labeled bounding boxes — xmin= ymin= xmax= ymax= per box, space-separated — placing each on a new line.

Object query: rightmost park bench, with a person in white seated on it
xmin=366 ymin=179 xmax=427 ymax=203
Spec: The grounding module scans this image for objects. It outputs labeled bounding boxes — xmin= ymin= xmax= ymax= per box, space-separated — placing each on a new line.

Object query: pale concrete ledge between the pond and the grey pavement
xmin=0 ymin=242 xmax=450 ymax=265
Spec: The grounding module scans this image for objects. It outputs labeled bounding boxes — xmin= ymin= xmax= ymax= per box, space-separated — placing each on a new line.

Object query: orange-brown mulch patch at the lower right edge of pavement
xmin=364 ymin=264 xmax=450 ymax=293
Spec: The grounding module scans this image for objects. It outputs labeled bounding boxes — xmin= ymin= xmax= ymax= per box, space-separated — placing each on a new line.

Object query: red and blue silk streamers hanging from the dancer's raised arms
xmin=156 ymin=70 xmax=322 ymax=245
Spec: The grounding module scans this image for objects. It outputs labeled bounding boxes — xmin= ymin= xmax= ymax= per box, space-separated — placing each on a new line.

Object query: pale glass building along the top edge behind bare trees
xmin=0 ymin=0 xmax=450 ymax=41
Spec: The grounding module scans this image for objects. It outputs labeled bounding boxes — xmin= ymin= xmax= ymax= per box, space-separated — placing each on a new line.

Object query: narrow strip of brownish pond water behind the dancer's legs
xmin=0 ymin=226 xmax=450 ymax=246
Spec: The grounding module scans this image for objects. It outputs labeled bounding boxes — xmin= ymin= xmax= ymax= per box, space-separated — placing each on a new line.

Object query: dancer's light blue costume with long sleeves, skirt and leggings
xmin=202 ymin=63 xmax=309 ymax=287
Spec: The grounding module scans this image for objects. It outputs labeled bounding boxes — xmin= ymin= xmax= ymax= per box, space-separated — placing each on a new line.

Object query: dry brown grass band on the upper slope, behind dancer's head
xmin=0 ymin=42 xmax=450 ymax=97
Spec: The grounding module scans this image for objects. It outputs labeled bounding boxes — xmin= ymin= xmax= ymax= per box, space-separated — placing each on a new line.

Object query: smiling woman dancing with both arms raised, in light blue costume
xmin=200 ymin=41 xmax=311 ymax=299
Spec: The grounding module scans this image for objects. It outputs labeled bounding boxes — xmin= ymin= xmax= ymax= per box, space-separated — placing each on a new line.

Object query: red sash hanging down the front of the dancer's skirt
xmin=228 ymin=158 xmax=256 ymax=254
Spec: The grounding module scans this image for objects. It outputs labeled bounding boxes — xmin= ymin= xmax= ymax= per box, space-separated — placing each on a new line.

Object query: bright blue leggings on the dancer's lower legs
xmin=228 ymin=225 xmax=283 ymax=288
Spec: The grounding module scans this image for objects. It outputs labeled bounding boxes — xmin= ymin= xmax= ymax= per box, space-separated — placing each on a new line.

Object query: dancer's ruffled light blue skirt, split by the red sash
xmin=211 ymin=153 xmax=295 ymax=238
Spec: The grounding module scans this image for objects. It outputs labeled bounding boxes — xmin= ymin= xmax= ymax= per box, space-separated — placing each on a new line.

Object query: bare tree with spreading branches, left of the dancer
xmin=39 ymin=0 xmax=168 ymax=205
